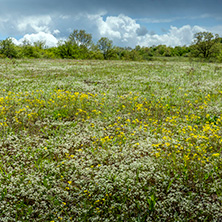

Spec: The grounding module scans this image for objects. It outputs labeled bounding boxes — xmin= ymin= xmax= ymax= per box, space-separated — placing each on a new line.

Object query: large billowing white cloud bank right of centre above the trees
xmin=88 ymin=15 xmax=206 ymax=47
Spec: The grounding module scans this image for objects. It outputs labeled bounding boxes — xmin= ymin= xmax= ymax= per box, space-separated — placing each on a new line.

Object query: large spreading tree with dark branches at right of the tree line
xmin=193 ymin=32 xmax=219 ymax=58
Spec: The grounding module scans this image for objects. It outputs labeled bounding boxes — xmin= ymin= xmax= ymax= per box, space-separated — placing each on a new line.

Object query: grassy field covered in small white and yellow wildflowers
xmin=0 ymin=60 xmax=222 ymax=222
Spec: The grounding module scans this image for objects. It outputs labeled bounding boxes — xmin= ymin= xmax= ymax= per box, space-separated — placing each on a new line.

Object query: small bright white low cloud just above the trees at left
xmin=12 ymin=32 xmax=58 ymax=47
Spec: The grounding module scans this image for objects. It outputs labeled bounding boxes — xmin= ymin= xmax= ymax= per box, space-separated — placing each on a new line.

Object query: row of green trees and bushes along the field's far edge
xmin=0 ymin=30 xmax=222 ymax=62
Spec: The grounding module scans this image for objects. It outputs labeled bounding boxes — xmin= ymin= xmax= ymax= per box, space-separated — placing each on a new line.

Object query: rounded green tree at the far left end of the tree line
xmin=0 ymin=38 xmax=17 ymax=58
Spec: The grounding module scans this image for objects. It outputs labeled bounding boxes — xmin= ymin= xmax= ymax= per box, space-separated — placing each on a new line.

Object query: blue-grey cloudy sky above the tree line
xmin=0 ymin=0 xmax=222 ymax=47
